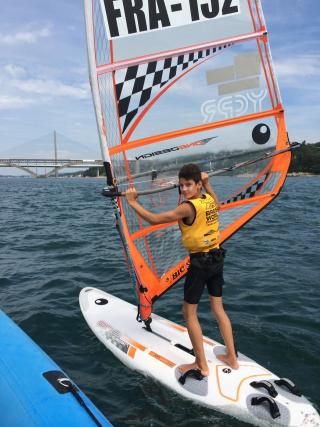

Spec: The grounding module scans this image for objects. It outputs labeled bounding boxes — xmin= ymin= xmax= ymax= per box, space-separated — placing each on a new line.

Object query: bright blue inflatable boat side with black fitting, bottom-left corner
xmin=0 ymin=310 xmax=112 ymax=427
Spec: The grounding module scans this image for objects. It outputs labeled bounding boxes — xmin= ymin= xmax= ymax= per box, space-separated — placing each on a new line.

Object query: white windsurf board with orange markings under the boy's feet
xmin=79 ymin=288 xmax=320 ymax=427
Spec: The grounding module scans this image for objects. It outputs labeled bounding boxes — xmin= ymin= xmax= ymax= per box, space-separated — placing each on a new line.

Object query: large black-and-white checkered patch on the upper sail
xmin=115 ymin=45 xmax=230 ymax=133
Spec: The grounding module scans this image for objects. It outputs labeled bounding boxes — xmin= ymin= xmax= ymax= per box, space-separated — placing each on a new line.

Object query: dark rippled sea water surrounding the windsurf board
xmin=0 ymin=177 xmax=320 ymax=427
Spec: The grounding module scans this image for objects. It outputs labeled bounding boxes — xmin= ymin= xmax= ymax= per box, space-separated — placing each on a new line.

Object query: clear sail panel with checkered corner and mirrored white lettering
xmin=115 ymin=41 xmax=276 ymax=141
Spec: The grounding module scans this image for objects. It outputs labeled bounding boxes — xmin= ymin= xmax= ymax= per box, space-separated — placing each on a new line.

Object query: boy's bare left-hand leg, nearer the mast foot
xmin=179 ymin=302 xmax=209 ymax=376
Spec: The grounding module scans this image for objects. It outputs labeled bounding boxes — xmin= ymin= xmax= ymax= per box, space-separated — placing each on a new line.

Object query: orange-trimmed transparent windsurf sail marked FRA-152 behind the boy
xmin=84 ymin=0 xmax=291 ymax=321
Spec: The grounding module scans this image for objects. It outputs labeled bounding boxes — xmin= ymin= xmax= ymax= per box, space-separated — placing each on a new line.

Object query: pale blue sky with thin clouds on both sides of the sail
xmin=0 ymin=0 xmax=320 ymax=168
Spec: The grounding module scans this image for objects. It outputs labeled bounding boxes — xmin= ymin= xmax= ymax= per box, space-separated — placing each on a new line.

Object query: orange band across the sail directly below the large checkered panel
xmin=109 ymin=106 xmax=283 ymax=156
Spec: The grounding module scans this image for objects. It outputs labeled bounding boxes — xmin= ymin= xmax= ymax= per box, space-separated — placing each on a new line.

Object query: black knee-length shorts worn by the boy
xmin=184 ymin=248 xmax=225 ymax=304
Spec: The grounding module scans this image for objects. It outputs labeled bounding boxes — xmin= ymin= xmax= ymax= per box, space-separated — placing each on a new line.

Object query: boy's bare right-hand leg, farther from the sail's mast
xmin=209 ymin=296 xmax=239 ymax=369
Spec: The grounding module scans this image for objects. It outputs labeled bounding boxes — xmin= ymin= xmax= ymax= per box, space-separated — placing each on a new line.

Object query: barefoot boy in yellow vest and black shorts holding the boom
xmin=126 ymin=164 xmax=239 ymax=376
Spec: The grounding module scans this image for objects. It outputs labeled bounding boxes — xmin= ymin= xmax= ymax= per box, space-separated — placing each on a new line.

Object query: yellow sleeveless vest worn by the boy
xmin=179 ymin=194 xmax=220 ymax=253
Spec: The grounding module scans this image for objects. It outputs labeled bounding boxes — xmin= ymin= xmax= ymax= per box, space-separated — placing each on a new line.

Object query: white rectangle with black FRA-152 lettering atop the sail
xmin=104 ymin=0 xmax=240 ymax=38
